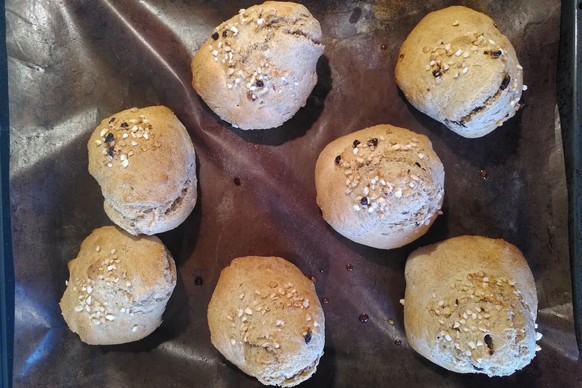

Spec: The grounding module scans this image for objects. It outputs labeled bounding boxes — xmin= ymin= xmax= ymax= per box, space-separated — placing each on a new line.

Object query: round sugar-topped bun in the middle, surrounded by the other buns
xmin=315 ymin=124 xmax=445 ymax=249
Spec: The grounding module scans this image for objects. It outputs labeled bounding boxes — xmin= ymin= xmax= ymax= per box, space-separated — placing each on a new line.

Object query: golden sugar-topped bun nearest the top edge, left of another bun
xmin=192 ymin=1 xmax=324 ymax=129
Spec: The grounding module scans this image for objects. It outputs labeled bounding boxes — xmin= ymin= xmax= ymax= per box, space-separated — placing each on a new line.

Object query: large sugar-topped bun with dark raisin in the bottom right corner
xmin=404 ymin=236 xmax=541 ymax=376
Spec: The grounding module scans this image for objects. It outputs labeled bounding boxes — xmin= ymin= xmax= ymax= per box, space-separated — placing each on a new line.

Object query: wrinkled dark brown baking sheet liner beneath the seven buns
xmin=5 ymin=0 xmax=581 ymax=387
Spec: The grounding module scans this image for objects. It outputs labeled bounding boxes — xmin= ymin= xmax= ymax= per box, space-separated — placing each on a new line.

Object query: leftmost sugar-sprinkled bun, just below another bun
xmin=60 ymin=226 xmax=176 ymax=345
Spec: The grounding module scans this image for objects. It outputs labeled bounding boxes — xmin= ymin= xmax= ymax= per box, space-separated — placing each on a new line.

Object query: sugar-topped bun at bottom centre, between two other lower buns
xmin=208 ymin=256 xmax=325 ymax=387
